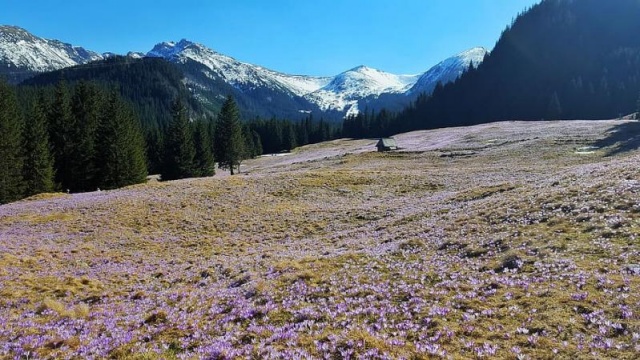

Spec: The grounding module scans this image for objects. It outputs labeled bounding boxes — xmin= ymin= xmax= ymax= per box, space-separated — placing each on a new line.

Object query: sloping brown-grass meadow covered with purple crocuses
xmin=0 ymin=121 xmax=640 ymax=359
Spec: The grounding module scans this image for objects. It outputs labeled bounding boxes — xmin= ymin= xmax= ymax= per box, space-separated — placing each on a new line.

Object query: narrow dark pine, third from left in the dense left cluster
xmin=49 ymin=81 xmax=75 ymax=190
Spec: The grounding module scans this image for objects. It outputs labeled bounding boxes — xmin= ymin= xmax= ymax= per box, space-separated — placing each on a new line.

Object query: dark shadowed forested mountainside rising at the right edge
xmin=397 ymin=0 xmax=640 ymax=131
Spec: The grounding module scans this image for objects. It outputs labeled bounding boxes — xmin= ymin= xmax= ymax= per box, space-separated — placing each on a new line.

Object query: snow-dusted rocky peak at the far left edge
xmin=0 ymin=26 xmax=103 ymax=83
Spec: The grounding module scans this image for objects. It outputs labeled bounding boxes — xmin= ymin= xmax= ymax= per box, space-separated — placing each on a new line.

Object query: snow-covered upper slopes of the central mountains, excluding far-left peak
xmin=147 ymin=39 xmax=487 ymax=114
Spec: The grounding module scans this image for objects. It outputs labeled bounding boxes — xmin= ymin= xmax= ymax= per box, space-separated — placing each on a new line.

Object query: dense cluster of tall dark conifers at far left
xmin=0 ymin=82 xmax=147 ymax=203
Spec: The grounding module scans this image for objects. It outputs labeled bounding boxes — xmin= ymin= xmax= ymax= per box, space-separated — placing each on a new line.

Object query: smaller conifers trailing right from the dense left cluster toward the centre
xmin=157 ymin=96 xmax=341 ymax=180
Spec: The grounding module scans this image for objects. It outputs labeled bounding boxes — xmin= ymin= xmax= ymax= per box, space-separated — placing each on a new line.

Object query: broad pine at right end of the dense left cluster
xmin=96 ymin=91 xmax=147 ymax=189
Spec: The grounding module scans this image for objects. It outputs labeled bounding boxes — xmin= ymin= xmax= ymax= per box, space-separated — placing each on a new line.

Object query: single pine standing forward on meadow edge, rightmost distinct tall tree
xmin=215 ymin=96 xmax=245 ymax=175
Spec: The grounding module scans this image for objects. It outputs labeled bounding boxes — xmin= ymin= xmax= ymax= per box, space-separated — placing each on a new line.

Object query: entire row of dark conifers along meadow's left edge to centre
xmin=0 ymin=75 xmax=340 ymax=203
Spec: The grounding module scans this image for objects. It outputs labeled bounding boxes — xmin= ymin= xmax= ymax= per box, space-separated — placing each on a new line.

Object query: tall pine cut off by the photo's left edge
xmin=0 ymin=81 xmax=24 ymax=204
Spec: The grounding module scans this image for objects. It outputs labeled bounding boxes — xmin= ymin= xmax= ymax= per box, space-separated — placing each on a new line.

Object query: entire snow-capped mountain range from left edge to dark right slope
xmin=0 ymin=26 xmax=488 ymax=119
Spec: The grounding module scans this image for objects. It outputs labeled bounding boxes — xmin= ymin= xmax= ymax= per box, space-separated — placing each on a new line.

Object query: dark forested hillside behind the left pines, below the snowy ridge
xmin=20 ymin=57 xmax=340 ymax=158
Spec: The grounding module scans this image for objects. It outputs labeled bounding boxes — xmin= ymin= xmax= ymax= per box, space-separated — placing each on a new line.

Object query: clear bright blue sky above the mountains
xmin=0 ymin=0 xmax=539 ymax=75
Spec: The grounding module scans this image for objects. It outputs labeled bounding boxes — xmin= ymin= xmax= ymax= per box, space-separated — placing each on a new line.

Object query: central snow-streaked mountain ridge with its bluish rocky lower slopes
xmin=147 ymin=39 xmax=487 ymax=118
